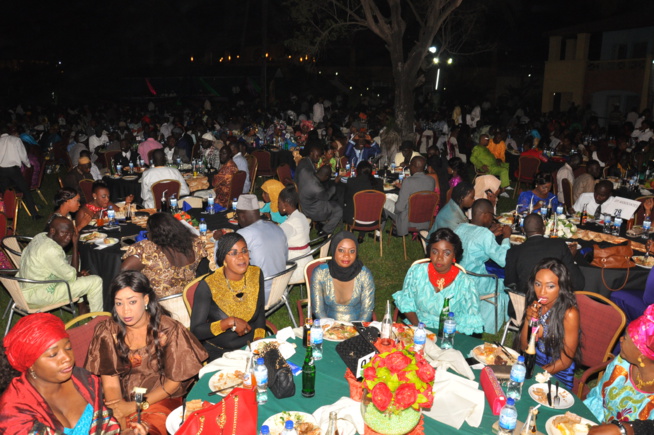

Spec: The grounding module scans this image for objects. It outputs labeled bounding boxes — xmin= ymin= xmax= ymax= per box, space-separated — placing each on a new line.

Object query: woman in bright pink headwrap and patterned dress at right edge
xmin=584 ymin=305 xmax=654 ymax=424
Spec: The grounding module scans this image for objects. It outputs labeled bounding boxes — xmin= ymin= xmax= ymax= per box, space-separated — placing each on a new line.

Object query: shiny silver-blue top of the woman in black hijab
xmin=311 ymin=264 xmax=375 ymax=322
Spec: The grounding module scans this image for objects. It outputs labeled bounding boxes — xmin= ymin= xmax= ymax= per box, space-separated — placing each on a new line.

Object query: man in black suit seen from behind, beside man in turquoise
xmin=504 ymin=214 xmax=585 ymax=294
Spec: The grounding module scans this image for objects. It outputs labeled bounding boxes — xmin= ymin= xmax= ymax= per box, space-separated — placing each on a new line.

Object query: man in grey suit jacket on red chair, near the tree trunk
xmin=384 ymin=156 xmax=436 ymax=236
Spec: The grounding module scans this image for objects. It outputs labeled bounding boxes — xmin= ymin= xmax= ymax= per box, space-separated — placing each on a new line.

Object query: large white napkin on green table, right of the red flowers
xmin=424 ymin=368 xmax=486 ymax=429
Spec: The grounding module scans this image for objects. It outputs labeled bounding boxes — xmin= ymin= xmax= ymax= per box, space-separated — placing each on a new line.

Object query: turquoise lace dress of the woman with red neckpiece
xmin=393 ymin=263 xmax=484 ymax=334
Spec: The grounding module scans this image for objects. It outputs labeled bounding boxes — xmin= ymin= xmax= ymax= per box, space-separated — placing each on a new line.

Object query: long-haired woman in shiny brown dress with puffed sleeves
xmin=85 ymin=271 xmax=207 ymax=434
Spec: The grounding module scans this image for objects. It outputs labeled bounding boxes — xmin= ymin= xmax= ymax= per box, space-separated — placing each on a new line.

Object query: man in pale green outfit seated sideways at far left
xmin=18 ymin=216 xmax=103 ymax=314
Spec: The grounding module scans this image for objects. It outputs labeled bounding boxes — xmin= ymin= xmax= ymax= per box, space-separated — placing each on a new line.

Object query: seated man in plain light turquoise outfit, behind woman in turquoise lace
xmin=454 ymin=198 xmax=511 ymax=334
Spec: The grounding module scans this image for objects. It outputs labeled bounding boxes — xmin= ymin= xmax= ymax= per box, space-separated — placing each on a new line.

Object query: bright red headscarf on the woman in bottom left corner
xmin=3 ymin=313 xmax=68 ymax=373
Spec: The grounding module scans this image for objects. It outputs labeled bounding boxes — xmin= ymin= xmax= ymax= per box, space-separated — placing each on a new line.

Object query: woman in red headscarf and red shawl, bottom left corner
xmin=0 ymin=313 xmax=146 ymax=435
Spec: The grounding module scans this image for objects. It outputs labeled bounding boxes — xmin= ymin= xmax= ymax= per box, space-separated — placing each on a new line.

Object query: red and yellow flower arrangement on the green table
xmin=361 ymin=349 xmax=436 ymax=412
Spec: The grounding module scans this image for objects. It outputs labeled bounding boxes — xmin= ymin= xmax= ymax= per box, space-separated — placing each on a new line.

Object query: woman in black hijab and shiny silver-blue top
xmin=311 ymin=231 xmax=375 ymax=322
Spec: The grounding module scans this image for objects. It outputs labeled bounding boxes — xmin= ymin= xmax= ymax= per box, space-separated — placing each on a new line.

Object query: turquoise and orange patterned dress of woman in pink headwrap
xmin=584 ymin=355 xmax=654 ymax=423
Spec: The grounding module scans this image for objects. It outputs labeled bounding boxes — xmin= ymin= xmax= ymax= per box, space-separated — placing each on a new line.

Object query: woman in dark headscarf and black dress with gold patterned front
xmin=191 ymin=233 xmax=266 ymax=361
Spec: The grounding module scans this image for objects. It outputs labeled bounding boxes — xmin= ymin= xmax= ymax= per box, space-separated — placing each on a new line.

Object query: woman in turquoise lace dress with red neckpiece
xmin=393 ymin=228 xmax=484 ymax=334
